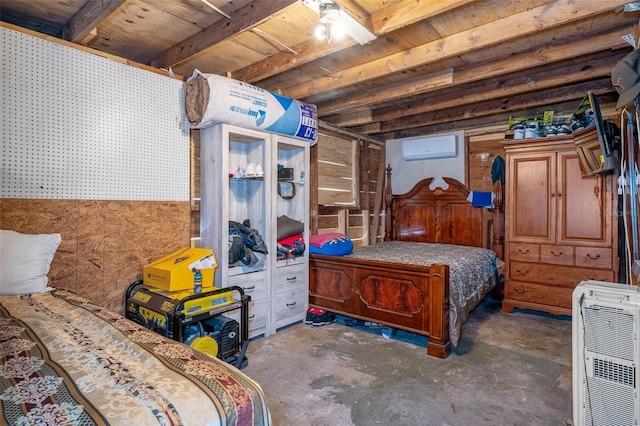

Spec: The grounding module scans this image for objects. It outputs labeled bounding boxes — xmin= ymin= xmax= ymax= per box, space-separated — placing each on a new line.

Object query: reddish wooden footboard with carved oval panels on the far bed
xmin=309 ymin=254 xmax=451 ymax=358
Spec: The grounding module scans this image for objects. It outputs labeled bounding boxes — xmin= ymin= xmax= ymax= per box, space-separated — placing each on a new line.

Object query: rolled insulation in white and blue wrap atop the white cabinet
xmin=185 ymin=70 xmax=318 ymax=145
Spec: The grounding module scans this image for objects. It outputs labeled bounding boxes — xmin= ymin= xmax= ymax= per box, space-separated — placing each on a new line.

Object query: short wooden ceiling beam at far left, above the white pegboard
xmin=60 ymin=0 xmax=126 ymax=45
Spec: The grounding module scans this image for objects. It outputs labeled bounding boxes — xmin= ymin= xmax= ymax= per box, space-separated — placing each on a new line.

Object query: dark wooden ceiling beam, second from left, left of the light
xmin=150 ymin=0 xmax=299 ymax=68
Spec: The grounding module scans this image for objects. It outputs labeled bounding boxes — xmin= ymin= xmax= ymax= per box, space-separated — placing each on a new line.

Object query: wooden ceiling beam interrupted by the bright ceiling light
xmin=232 ymin=0 xmax=471 ymax=83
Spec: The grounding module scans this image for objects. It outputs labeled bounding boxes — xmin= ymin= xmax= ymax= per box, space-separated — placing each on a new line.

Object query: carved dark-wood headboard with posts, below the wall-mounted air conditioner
xmin=384 ymin=167 xmax=504 ymax=259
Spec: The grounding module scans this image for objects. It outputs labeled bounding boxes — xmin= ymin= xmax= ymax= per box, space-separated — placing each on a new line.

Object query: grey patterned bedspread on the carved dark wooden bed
xmin=346 ymin=241 xmax=501 ymax=347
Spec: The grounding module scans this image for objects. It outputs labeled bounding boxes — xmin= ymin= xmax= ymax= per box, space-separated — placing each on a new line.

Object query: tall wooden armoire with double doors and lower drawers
xmin=502 ymin=137 xmax=618 ymax=315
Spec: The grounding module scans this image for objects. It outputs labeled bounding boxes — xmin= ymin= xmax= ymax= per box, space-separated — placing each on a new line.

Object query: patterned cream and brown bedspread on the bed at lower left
xmin=0 ymin=290 xmax=270 ymax=425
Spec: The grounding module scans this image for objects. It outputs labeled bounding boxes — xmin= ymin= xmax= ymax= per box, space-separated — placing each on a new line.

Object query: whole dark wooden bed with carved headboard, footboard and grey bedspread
xmin=309 ymin=170 xmax=504 ymax=358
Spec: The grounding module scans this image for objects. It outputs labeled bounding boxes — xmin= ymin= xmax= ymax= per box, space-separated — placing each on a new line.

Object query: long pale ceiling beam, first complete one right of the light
xmin=283 ymin=0 xmax=625 ymax=99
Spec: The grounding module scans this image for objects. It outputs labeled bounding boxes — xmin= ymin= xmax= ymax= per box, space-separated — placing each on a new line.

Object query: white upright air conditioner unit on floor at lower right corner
xmin=572 ymin=281 xmax=640 ymax=426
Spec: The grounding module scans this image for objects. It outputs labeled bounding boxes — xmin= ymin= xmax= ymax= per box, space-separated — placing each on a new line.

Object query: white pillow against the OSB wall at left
xmin=0 ymin=230 xmax=62 ymax=296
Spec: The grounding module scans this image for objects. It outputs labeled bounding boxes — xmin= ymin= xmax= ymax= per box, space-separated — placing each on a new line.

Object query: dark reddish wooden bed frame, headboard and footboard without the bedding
xmin=309 ymin=167 xmax=504 ymax=358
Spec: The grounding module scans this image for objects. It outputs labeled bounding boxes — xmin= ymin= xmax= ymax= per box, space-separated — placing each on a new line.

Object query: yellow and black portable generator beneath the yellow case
xmin=126 ymin=280 xmax=251 ymax=368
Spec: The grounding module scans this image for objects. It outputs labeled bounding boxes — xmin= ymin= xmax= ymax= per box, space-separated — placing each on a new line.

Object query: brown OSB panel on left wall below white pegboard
xmin=0 ymin=199 xmax=190 ymax=312
